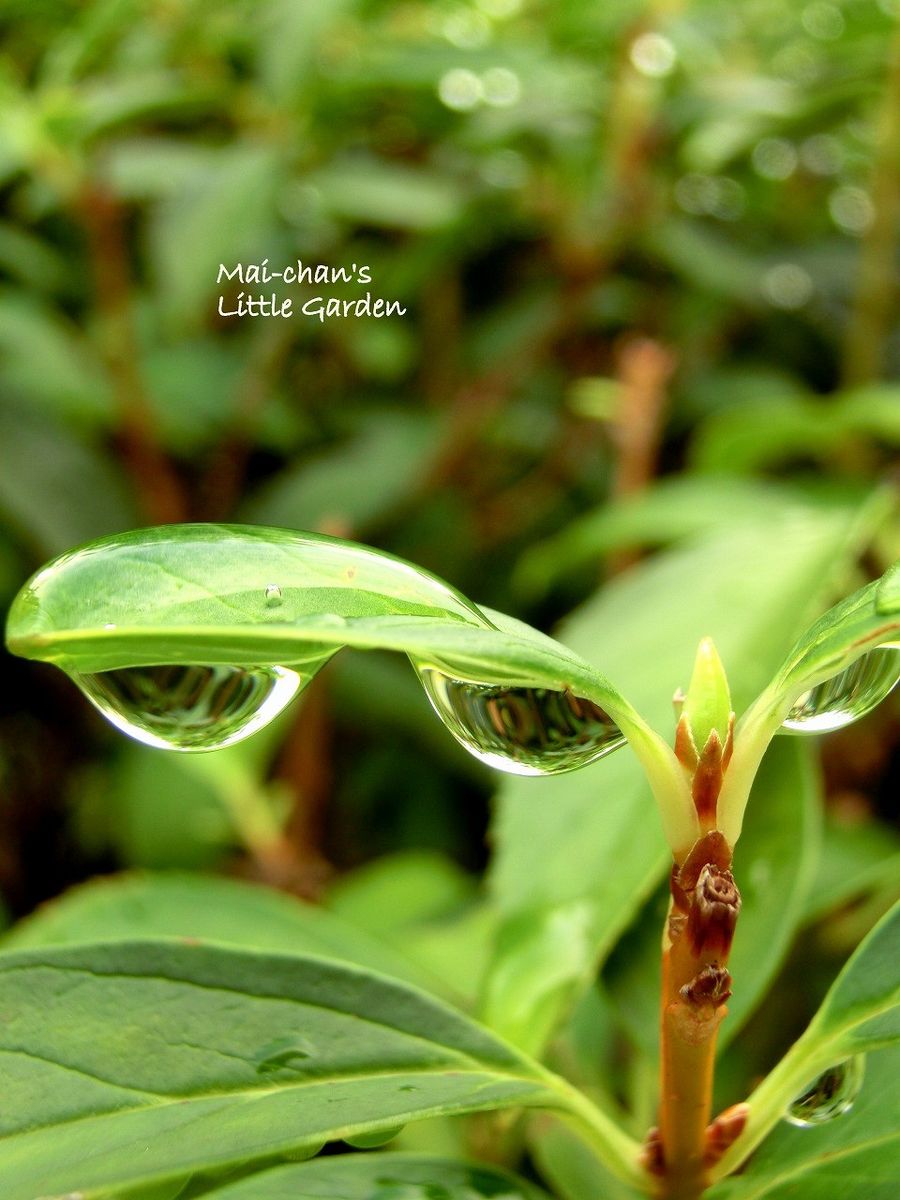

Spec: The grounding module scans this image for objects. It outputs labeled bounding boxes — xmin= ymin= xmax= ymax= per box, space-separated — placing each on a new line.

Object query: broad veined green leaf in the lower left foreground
xmin=0 ymin=942 xmax=640 ymax=1200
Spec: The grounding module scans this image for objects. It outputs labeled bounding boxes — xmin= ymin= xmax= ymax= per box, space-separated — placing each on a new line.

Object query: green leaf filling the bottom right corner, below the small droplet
xmin=707 ymin=1049 xmax=900 ymax=1200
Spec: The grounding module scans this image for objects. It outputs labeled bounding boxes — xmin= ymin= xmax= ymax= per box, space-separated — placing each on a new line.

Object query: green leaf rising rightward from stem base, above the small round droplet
xmin=713 ymin=904 xmax=900 ymax=1178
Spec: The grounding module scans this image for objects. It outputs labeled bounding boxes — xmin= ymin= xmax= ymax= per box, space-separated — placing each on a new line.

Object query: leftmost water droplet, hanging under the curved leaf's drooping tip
xmin=73 ymin=666 xmax=304 ymax=750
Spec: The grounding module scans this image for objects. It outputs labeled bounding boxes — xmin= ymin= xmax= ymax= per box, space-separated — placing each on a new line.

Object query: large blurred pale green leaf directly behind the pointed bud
xmin=484 ymin=506 xmax=877 ymax=1050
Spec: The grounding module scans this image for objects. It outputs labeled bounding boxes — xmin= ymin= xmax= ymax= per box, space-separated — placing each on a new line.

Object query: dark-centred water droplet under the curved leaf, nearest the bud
xmin=414 ymin=664 xmax=625 ymax=775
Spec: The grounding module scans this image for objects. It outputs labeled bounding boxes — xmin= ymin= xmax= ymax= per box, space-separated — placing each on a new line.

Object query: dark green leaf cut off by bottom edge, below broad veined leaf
xmin=180 ymin=1153 xmax=547 ymax=1200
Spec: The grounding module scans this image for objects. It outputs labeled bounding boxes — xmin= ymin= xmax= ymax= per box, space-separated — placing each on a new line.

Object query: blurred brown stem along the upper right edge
xmin=844 ymin=22 xmax=900 ymax=386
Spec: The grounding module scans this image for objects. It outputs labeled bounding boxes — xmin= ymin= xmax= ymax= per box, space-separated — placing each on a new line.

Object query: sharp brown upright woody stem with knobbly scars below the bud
xmin=660 ymin=832 xmax=740 ymax=1200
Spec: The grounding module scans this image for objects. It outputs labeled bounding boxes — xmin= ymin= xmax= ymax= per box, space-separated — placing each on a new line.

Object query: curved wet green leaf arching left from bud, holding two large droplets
xmin=7 ymin=524 xmax=696 ymax=844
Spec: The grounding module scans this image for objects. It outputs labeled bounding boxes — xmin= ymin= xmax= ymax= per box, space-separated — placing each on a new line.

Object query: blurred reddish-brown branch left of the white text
xmin=77 ymin=182 xmax=187 ymax=524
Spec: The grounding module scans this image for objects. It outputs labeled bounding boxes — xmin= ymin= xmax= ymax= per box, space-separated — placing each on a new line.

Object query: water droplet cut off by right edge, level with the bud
xmin=782 ymin=647 xmax=900 ymax=733
